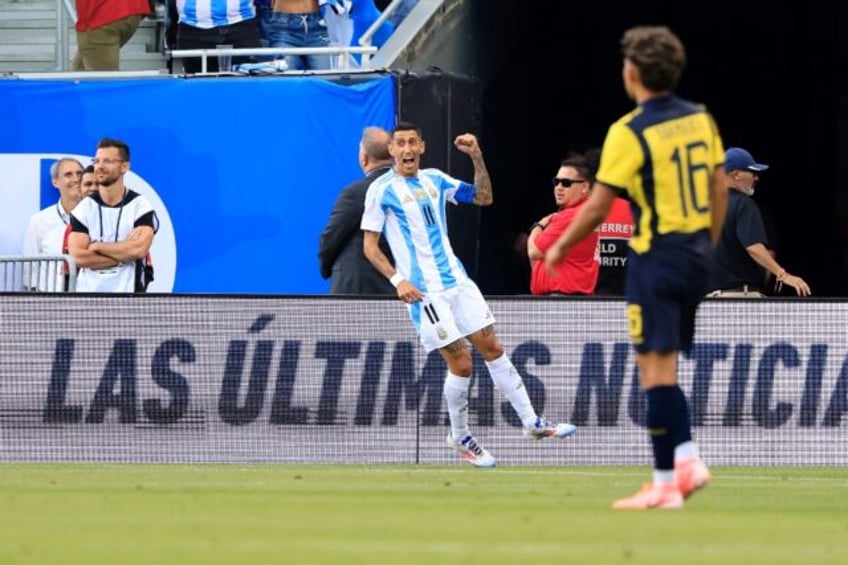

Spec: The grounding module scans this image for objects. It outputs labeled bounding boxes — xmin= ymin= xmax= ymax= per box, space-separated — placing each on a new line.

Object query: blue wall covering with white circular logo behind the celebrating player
xmin=0 ymin=73 xmax=477 ymax=294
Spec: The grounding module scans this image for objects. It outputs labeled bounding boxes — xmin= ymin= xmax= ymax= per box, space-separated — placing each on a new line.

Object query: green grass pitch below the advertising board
xmin=0 ymin=464 xmax=848 ymax=565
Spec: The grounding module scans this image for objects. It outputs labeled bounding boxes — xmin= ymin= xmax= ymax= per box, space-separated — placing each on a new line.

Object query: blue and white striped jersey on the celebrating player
xmin=360 ymin=169 xmax=476 ymax=293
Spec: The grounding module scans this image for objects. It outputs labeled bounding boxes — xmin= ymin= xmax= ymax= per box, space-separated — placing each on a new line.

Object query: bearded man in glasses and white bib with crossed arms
xmin=68 ymin=138 xmax=158 ymax=292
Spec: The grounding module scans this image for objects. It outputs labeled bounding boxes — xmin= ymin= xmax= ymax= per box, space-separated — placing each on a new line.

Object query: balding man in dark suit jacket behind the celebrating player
xmin=318 ymin=127 xmax=397 ymax=296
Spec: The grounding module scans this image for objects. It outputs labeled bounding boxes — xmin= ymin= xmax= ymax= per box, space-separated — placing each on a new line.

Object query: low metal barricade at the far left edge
xmin=0 ymin=255 xmax=77 ymax=292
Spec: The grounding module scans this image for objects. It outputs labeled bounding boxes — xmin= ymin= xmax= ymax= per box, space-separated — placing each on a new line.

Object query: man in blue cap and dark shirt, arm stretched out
xmin=707 ymin=147 xmax=810 ymax=298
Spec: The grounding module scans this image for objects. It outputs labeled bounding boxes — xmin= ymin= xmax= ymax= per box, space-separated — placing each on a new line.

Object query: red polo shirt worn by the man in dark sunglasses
xmin=530 ymin=200 xmax=599 ymax=294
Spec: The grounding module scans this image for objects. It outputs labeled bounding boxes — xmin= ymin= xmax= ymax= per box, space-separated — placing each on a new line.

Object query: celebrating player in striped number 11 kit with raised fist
xmin=361 ymin=122 xmax=577 ymax=467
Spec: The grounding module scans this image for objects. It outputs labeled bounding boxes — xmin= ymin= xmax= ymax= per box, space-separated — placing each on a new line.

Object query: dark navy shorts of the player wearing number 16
xmin=626 ymin=237 xmax=710 ymax=353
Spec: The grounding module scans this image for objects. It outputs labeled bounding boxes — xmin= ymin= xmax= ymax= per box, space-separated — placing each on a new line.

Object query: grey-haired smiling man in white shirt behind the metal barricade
xmin=22 ymin=158 xmax=83 ymax=292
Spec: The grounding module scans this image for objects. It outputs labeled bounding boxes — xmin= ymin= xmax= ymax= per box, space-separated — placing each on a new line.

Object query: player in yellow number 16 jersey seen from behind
xmin=545 ymin=26 xmax=727 ymax=509
